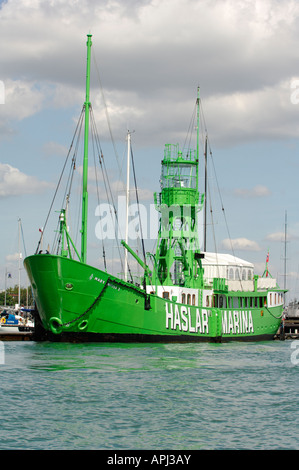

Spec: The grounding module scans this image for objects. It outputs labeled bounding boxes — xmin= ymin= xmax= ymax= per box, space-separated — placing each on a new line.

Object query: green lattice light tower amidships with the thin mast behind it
xmin=152 ymin=88 xmax=204 ymax=288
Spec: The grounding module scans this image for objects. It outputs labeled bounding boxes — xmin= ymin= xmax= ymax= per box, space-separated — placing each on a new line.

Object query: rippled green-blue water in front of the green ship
xmin=0 ymin=341 xmax=299 ymax=450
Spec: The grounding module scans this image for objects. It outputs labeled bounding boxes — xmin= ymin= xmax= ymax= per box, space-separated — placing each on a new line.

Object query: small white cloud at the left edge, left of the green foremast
xmin=0 ymin=163 xmax=50 ymax=197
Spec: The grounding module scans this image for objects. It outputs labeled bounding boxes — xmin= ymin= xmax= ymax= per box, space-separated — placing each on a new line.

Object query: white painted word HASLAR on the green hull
xmin=165 ymin=302 xmax=209 ymax=334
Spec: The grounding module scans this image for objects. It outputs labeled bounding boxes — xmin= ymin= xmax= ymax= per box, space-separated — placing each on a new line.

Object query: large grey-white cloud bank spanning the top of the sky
xmin=0 ymin=0 xmax=299 ymax=145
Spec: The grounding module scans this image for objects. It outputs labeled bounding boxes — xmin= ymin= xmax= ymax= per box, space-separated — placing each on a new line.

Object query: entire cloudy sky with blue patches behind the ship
xmin=0 ymin=0 xmax=299 ymax=297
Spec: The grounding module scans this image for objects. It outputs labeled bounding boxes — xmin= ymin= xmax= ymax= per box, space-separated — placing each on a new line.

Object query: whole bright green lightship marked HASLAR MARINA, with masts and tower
xmin=24 ymin=35 xmax=284 ymax=342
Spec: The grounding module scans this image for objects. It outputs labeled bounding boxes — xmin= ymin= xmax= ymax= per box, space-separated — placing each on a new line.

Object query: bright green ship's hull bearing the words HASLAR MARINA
xmin=24 ymin=254 xmax=282 ymax=342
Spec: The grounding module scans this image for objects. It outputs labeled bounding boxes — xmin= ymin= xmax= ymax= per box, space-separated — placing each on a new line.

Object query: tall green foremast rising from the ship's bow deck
xmin=81 ymin=34 xmax=92 ymax=263
